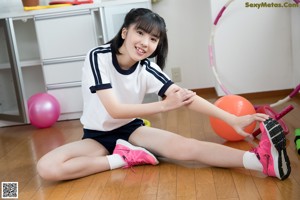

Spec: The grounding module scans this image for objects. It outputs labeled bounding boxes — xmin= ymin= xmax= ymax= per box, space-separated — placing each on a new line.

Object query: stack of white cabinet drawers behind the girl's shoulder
xmin=34 ymin=9 xmax=103 ymax=119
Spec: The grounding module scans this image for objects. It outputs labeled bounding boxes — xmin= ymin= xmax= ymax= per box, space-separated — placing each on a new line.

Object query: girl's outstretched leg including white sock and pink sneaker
xmin=130 ymin=119 xmax=291 ymax=180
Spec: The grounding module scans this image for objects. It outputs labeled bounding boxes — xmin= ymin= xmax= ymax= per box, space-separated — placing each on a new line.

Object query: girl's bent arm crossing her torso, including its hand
xmin=97 ymin=84 xmax=195 ymax=119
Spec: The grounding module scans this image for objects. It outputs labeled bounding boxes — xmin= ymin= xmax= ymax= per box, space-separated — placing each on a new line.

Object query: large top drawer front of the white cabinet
xmin=35 ymin=9 xmax=97 ymax=60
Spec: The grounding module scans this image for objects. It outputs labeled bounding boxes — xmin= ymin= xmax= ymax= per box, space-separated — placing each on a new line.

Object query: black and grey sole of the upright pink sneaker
xmin=263 ymin=118 xmax=291 ymax=180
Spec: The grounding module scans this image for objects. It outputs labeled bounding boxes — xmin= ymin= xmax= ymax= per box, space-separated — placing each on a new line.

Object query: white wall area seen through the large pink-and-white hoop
xmin=211 ymin=0 xmax=292 ymax=94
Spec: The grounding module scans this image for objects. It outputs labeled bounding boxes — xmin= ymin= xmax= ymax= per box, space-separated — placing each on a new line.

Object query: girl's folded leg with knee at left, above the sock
xmin=37 ymin=139 xmax=110 ymax=181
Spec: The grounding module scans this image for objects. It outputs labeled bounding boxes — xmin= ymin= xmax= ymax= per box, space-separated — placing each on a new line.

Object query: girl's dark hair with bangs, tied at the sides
xmin=108 ymin=8 xmax=168 ymax=69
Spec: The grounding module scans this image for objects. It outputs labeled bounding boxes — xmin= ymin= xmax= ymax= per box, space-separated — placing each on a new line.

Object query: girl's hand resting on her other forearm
xmin=162 ymin=87 xmax=196 ymax=111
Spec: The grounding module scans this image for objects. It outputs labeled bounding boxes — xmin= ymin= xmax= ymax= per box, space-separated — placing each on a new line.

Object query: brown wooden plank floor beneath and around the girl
xmin=0 ymin=94 xmax=300 ymax=200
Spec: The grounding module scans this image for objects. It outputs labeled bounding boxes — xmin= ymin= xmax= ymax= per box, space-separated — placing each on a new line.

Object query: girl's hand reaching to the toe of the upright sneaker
xmin=231 ymin=113 xmax=269 ymax=139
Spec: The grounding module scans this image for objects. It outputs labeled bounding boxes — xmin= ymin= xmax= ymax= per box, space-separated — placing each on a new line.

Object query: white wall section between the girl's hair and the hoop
xmin=152 ymin=0 xmax=214 ymax=89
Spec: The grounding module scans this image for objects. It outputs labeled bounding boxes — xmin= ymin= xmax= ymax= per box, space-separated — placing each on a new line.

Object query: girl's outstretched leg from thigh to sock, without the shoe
xmin=129 ymin=127 xmax=245 ymax=168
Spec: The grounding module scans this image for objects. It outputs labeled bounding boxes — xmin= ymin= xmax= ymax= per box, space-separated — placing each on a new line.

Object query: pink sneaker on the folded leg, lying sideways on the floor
xmin=113 ymin=139 xmax=159 ymax=168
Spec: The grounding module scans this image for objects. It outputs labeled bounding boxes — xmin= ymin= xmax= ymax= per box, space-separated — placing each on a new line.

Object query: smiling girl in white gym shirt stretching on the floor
xmin=37 ymin=8 xmax=291 ymax=181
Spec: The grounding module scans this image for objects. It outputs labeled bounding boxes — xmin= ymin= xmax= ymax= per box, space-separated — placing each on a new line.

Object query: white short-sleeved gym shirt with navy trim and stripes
xmin=80 ymin=44 xmax=173 ymax=131
